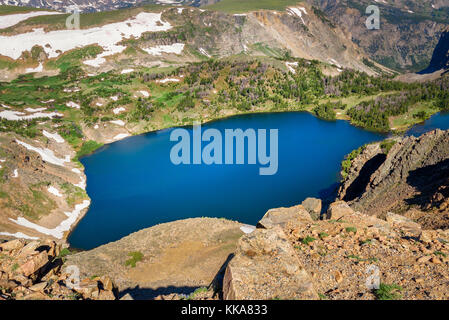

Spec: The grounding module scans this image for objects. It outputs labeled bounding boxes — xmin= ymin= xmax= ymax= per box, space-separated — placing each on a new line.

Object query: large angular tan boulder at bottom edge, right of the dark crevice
xmin=223 ymin=226 xmax=318 ymax=300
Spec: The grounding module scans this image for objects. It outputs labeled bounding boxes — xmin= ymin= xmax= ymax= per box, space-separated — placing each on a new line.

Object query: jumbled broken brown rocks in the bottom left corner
xmin=0 ymin=239 xmax=115 ymax=300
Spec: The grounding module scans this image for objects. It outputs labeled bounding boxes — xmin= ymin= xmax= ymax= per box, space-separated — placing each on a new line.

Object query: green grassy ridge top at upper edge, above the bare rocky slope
xmin=206 ymin=0 xmax=302 ymax=13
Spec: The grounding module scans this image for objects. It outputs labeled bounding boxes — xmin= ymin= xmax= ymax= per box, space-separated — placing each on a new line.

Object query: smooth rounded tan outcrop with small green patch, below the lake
xmin=65 ymin=218 xmax=244 ymax=300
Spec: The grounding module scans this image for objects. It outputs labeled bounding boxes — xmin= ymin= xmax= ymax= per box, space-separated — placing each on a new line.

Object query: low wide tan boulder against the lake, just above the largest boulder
xmin=257 ymin=205 xmax=313 ymax=229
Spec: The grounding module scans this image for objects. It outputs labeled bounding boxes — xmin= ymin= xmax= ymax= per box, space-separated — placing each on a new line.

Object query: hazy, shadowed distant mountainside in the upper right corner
xmin=308 ymin=0 xmax=449 ymax=72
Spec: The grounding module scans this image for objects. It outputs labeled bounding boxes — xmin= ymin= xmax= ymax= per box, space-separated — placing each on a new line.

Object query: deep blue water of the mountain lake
xmin=69 ymin=113 xmax=449 ymax=249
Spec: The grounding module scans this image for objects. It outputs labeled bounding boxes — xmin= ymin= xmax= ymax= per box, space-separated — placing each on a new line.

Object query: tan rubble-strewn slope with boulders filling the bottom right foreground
xmin=223 ymin=201 xmax=449 ymax=300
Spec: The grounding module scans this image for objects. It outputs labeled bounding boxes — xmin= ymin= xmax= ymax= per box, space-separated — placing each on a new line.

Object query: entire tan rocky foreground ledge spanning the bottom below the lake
xmin=0 ymin=199 xmax=449 ymax=300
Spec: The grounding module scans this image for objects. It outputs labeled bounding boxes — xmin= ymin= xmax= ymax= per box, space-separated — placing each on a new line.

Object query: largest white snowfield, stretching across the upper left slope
xmin=0 ymin=12 xmax=172 ymax=63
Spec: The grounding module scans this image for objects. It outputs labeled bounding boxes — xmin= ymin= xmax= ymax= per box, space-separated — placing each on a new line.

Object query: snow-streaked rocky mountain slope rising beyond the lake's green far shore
xmin=0 ymin=4 xmax=380 ymax=79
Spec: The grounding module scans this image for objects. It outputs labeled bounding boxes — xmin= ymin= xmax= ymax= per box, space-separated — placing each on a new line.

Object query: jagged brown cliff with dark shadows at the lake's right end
xmin=339 ymin=130 xmax=449 ymax=228
